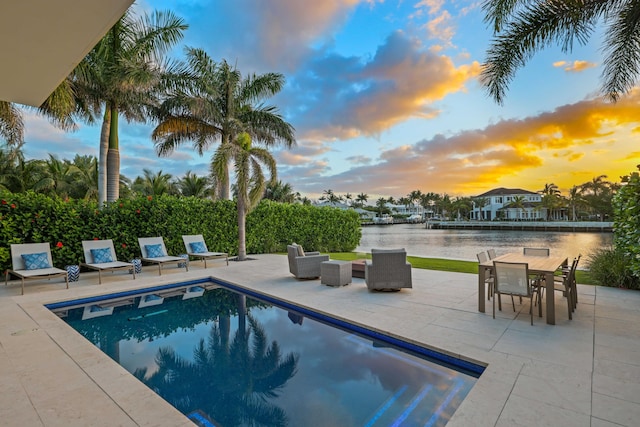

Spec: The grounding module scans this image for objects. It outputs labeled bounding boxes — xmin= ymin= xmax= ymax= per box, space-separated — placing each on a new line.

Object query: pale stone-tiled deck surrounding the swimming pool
xmin=0 ymin=255 xmax=640 ymax=427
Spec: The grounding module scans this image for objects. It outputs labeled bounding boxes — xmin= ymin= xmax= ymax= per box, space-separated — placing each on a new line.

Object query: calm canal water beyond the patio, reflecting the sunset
xmin=355 ymin=224 xmax=613 ymax=261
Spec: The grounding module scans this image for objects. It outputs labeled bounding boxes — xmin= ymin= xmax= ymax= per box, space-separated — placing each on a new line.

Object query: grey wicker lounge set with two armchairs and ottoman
xmin=287 ymin=243 xmax=412 ymax=291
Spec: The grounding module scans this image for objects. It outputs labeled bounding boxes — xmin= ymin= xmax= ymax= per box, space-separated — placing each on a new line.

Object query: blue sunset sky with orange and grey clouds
xmin=17 ymin=0 xmax=640 ymax=202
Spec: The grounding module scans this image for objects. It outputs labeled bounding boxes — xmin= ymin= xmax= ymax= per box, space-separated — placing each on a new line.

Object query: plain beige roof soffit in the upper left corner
xmin=0 ymin=0 xmax=134 ymax=107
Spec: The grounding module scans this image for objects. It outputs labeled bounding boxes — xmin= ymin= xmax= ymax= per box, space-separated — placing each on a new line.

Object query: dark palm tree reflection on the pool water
xmin=134 ymin=310 xmax=298 ymax=426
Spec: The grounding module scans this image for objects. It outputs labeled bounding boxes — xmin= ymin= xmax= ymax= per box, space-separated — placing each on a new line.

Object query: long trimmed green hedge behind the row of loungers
xmin=0 ymin=192 xmax=361 ymax=271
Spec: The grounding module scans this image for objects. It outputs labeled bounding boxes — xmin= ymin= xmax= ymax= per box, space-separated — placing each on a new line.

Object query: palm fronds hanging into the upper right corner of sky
xmin=480 ymin=0 xmax=640 ymax=104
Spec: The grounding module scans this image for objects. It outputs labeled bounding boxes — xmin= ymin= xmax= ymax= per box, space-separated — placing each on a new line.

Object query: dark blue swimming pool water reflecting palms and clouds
xmin=47 ymin=281 xmax=483 ymax=426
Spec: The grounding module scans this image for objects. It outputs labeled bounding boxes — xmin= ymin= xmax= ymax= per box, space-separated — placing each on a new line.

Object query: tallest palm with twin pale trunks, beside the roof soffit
xmin=73 ymin=9 xmax=187 ymax=204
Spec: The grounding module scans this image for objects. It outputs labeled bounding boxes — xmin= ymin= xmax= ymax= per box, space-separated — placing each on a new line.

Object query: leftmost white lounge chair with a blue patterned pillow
xmin=4 ymin=243 xmax=69 ymax=295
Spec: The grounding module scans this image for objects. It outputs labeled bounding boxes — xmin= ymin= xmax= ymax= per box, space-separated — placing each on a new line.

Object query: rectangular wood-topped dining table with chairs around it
xmin=478 ymin=252 xmax=568 ymax=325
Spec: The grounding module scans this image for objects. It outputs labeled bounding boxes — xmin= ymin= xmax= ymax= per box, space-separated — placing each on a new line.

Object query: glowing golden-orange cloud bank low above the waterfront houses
xmin=282 ymin=91 xmax=640 ymax=197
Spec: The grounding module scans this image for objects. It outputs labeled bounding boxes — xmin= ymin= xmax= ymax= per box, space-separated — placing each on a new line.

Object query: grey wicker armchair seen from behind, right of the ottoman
xmin=364 ymin=249 xmax=413 ymax=291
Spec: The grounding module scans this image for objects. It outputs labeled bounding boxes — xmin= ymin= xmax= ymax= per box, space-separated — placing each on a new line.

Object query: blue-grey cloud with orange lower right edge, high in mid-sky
xmin=283 ymin=31 xmax=480 ymax=141
